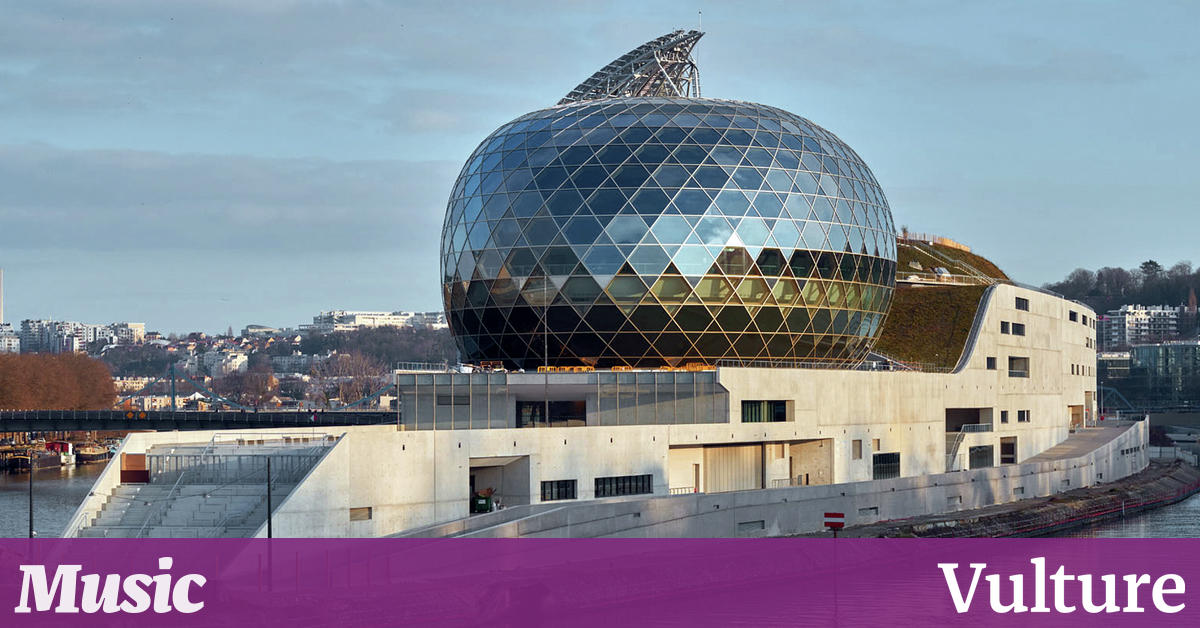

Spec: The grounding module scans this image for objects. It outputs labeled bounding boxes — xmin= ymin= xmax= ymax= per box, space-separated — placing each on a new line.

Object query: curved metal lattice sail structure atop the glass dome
xmin=558 ymin=29 xmax=704 ymax=104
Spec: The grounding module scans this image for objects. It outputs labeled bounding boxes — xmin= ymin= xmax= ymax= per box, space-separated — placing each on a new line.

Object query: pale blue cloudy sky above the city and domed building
xmin=0 ymin=0 xmax=1200 ymax=333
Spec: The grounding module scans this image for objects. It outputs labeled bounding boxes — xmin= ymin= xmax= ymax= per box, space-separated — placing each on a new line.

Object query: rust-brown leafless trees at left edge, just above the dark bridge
xmin=0 ymin=353 xmax=116 ymax=409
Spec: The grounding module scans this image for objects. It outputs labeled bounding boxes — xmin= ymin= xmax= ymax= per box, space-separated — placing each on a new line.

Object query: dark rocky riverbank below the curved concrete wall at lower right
xmin=820 ymin=461 xmax=1200 ymax=538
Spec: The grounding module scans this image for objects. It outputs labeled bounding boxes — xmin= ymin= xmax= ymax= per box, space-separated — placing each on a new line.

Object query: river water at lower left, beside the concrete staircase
xmin=0 ymin=465 xmax=104 ymax=537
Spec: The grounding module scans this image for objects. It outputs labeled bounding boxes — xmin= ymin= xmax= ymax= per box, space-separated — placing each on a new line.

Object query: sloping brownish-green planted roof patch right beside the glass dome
xmin=875 ymin=285 xmax=986 ymax=369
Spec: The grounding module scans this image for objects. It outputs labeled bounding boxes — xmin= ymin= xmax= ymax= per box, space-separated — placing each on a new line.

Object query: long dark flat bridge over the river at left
xmin=0 ymin=409 xmax=396 ymax=432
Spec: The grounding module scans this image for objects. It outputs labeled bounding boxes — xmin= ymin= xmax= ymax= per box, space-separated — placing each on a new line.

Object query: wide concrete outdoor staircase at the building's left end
xmin=79 ymin=443 xmax=331 ymax=538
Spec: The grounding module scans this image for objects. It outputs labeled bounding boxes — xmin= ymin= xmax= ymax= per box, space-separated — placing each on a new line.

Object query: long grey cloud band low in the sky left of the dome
xmin=0 ymin=144 xmax=460 ymax=254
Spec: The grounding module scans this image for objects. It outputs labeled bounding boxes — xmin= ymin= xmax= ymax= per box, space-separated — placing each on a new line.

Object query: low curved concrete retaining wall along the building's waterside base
xmin=439 ymin=423 xmax=1150 ymax=537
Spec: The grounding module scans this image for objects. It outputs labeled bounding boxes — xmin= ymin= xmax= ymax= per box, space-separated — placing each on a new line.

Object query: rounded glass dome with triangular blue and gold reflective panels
xmin=442 ymin=98 xmax=895 ymax=369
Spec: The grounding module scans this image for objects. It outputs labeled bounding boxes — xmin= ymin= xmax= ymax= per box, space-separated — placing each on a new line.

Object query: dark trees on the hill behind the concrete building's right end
xmin=1044 ymin=259 xmax=1200 ymax=313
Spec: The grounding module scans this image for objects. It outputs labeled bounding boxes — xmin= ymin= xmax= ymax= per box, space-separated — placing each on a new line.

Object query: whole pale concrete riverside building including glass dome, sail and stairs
xmin=67 ymin=31 xmax=1132 ymax=537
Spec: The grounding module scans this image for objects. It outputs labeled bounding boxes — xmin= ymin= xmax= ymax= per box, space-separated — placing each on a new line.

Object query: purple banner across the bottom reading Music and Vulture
xmin=0 ymin=539 xmax=1200 ymax=628
